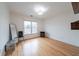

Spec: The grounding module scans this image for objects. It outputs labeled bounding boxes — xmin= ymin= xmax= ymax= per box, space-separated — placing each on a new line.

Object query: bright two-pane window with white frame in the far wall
xmin=24 ymin=21 xmax=37 ymax=34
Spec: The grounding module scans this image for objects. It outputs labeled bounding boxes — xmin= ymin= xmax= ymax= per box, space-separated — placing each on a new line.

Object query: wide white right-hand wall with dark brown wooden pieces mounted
xmin=45 ymin=3 xmax=79 ymax=47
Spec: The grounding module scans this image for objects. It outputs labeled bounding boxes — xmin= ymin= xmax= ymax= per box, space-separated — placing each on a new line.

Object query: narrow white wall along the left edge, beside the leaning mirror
xmin=0 ymin=3 xmax=9 ymax=55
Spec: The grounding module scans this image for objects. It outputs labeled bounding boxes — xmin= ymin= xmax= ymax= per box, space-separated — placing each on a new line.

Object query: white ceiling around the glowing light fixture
xmin=7 ymin=2 xmax=70 ymax=19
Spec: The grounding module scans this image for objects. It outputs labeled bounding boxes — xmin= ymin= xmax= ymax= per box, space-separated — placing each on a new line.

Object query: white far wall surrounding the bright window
xmin=10 ymin=12 xmax=43 ymax=39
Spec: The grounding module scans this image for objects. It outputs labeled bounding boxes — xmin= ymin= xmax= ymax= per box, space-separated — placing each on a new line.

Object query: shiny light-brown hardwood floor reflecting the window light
xmin=7 ymin=38 xmax=79 ymax=56
